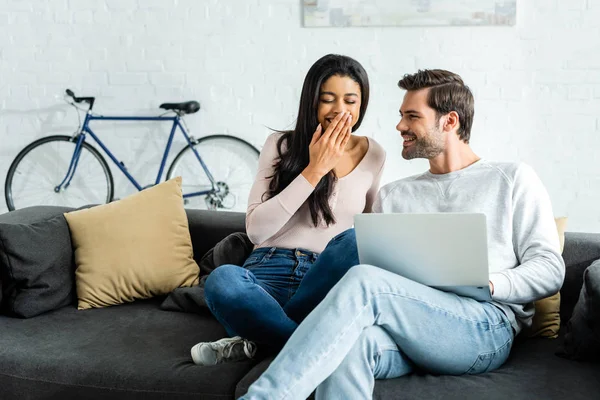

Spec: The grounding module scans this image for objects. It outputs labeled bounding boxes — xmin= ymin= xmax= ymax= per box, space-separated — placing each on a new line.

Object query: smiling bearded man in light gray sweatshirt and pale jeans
xmin=243 ymin=70 xmax=565 ymax=399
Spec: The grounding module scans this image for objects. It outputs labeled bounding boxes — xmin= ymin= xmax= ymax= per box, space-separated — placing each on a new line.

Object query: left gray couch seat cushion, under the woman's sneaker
xmin=0 ymin=297 xmax=252 ymax=399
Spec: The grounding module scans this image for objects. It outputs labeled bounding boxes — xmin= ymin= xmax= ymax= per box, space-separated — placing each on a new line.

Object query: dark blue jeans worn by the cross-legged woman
xmin=204 ymin=229 xmax=358 ymax=349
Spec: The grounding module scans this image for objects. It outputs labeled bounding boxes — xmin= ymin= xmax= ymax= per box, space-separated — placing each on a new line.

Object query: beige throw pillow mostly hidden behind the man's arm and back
xmin=527 ymin=217 xmax=567 ymax=339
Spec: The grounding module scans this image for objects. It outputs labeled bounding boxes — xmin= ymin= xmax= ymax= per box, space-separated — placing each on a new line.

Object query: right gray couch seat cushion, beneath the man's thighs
xmin=236 ymin=335 xmax=600 ymax=400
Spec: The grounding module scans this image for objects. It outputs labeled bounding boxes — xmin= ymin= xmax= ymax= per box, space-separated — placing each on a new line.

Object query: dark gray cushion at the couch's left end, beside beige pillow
xmin=0 ymin=209 xmax=75 ymax=318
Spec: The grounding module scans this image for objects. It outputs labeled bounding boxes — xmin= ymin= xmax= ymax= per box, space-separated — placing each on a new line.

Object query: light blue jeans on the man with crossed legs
xmin=242 ymin=265 xmax=513 ymax=400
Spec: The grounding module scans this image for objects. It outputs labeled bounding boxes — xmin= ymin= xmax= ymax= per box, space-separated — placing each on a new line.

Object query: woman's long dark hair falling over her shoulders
xmin=265 ymin=54 xmax=369 ymax=227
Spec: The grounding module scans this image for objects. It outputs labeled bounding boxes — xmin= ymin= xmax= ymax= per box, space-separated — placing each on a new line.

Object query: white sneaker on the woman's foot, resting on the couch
xmin=190 ymin=336 xmax=256 ymax=365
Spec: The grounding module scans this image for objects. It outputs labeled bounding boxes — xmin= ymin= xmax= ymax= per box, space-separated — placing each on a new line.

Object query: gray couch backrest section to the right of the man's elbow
xmin=560 ymin=232 xmax=600 ymax=323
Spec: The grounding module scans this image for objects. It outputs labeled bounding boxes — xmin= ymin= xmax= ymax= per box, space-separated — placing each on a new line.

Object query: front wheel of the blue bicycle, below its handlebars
xmin=4 ymin=135 xmax=114 ymax=211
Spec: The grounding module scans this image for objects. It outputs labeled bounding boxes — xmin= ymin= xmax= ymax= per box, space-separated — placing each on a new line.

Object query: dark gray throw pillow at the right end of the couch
xmin=558 ymin=260 xmax=600 ymax=361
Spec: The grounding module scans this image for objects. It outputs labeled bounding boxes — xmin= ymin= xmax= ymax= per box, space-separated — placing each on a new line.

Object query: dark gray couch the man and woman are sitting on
xmin=0 ymin=207 xmax=600 ymax=400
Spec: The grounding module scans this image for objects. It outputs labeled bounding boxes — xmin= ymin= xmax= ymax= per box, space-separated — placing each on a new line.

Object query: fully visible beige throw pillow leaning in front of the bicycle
xmin=65 ymin=177 xmax=199 ymax=310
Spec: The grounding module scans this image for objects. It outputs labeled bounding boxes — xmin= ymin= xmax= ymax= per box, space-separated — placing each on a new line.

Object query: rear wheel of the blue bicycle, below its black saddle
xmin=167 ymin=135 xmax=259 ymax=212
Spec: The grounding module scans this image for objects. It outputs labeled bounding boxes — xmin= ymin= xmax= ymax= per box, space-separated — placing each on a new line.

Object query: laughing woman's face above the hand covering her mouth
xmin=317 ymin=75 xmax=361 ymax=131
